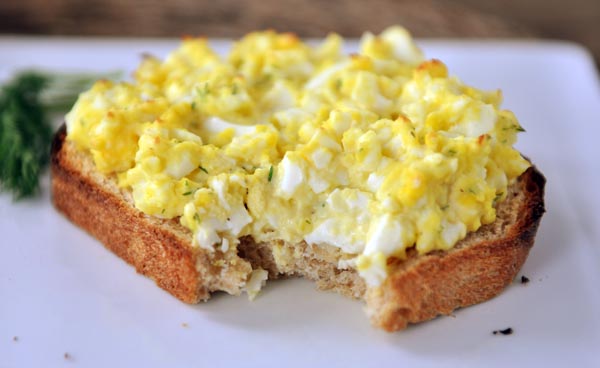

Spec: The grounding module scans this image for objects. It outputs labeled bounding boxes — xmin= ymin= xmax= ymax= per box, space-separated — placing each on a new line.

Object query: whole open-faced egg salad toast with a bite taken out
xmin=52 ymin=27 xmax=544 ymax=330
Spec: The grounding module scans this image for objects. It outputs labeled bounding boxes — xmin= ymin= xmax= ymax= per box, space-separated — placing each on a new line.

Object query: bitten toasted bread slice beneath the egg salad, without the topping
xmin=52 ymin=126 xmax=545 ymax=331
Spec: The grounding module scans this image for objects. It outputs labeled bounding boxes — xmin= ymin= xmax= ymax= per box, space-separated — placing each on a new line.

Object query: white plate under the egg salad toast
xmin=0 ymin=37 xmax=600 ymax=367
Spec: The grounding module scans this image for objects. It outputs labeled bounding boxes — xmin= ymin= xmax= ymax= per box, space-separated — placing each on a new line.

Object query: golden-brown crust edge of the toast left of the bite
xmin=51 ymin=126 xmax=209 ymax=303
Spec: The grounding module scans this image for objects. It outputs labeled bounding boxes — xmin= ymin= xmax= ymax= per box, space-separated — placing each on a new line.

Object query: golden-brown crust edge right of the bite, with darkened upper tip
xmin=365 ymin=167 xmax=546 ymax=331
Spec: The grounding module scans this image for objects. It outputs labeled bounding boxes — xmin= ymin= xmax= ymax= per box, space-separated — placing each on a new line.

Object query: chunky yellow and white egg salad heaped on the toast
xmin=66 ymin=27 xmax=529 ymax=285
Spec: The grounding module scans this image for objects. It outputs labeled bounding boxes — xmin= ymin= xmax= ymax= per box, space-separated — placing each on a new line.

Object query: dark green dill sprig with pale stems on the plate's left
xmin=0 ymin=71 xmax=116 ymax=199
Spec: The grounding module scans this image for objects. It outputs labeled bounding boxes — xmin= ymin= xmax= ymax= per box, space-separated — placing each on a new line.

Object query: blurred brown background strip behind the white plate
xmin=0 ymin=0 xmax=600 ymax=61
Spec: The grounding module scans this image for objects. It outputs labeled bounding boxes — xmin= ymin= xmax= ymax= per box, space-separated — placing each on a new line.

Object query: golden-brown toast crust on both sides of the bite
xmin=51 ymin=126 xmax=545 ymax=331
